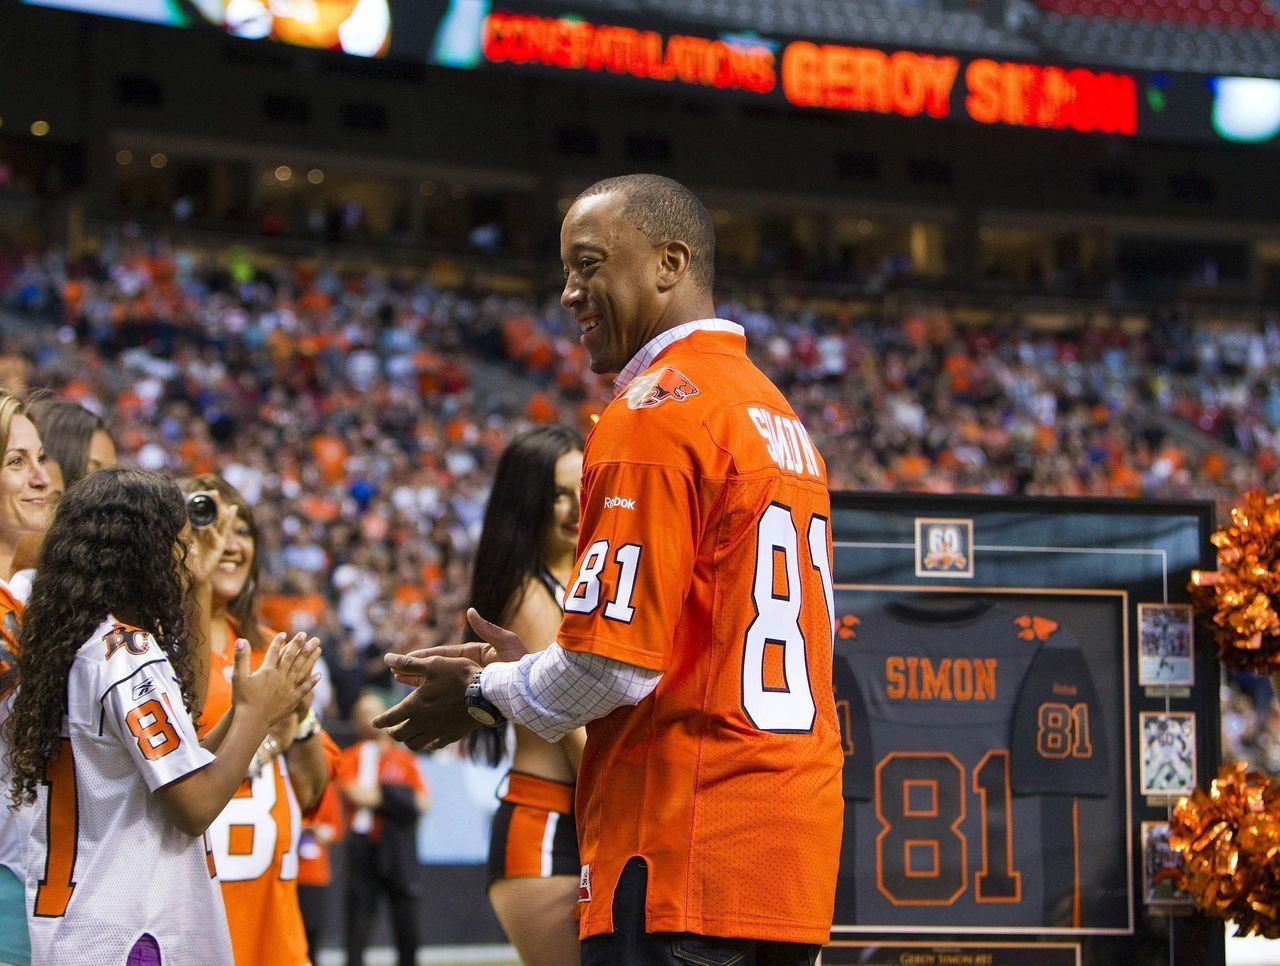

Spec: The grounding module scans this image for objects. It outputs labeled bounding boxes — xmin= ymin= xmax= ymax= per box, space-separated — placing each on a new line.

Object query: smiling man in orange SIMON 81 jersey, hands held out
xmin=375 ymin=175 xmax=844 ymax=966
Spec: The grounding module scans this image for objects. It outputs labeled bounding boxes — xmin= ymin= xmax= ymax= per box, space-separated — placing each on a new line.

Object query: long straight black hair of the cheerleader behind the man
xmin=463 ymin=426 xmax=582 ymax=765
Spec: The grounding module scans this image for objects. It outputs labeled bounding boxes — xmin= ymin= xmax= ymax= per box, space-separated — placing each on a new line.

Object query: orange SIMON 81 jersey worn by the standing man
xmin=558 ymin=326 xmax=844 ymax=943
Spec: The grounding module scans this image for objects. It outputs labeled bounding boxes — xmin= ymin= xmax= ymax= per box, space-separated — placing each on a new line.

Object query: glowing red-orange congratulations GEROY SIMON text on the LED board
xmin=480 ymin=9 xmax=1138 ymax=134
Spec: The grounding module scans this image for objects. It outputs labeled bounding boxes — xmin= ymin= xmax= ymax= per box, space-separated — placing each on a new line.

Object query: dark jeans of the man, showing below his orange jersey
xmin=582 ymin=859 xmax=820 ymax=966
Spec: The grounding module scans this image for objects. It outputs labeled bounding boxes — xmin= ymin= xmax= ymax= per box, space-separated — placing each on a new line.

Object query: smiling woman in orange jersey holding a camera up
xmin=179 ymin=473 xmax=338 ymax=966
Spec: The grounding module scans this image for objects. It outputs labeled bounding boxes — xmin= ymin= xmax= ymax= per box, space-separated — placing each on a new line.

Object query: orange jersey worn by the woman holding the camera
xmin=200 ymin=628 xmax=339 ymax=966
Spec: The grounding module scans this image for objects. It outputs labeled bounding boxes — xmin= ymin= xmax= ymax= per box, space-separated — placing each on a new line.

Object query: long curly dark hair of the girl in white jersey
xmin=5 ymin=470 xmax=195 ymax=804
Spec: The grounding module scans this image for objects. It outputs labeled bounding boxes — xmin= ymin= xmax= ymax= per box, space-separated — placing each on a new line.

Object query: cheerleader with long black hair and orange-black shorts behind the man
xmin=465 ymin=426 xmax=585 ymax=966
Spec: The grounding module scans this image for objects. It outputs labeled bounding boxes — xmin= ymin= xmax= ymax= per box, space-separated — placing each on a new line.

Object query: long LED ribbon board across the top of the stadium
xmin=23 ymin=0 xmax=1280 ymax=143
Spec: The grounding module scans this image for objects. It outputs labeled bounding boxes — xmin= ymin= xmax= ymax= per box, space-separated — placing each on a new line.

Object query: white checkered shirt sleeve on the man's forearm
xmin=480 ymin=644 xmax=662 ymax=741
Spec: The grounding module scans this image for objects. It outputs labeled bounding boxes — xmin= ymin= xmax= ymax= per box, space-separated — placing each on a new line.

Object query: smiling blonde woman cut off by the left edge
xmin=0 ymin=390 xmax=52 ymax=966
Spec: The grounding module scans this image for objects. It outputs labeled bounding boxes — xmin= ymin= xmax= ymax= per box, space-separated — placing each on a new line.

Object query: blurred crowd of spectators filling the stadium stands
xmin=0 ymin=235 xmax=1280 ymax=742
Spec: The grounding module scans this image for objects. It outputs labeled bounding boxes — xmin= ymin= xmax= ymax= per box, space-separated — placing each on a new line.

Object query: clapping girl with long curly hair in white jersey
xmin=6 ymin=470 xmax=319 ymax=966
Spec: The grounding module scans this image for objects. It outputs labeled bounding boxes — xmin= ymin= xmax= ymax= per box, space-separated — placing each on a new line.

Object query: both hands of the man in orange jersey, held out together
xmin=374 ymin=608 xmax=527 ymax=751
